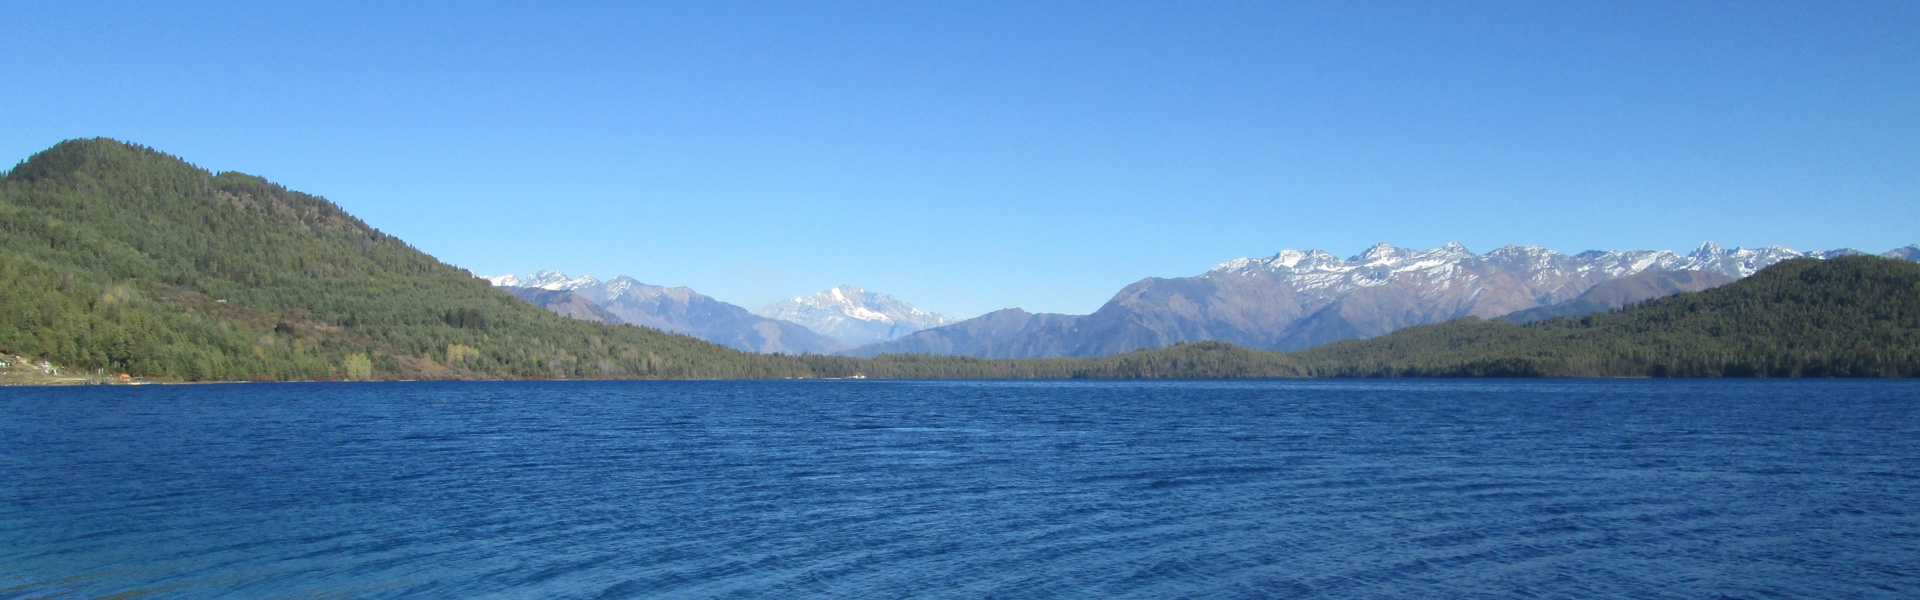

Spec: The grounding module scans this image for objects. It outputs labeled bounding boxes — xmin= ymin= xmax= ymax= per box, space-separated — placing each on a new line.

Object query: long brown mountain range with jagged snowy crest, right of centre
xmin=845 ymin=242 xmax=1920 ymax=358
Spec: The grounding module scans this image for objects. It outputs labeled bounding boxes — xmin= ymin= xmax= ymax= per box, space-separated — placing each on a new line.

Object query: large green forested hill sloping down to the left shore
xmin=0 ymin=138 xmax=835 ymax=381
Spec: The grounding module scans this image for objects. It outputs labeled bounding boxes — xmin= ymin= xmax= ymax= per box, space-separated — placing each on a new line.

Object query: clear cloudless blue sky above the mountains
xmin=0 ymin=2 xmax=1920 ymax=315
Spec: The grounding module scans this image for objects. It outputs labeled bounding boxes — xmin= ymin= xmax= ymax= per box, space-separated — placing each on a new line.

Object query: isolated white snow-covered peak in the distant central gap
xmin=760 ymin=285 xmax=960 ymax=346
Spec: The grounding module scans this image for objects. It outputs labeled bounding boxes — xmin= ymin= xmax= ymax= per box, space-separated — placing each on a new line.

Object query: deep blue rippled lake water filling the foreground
xmin=0 ymin=381 xmax=1920 ymax=598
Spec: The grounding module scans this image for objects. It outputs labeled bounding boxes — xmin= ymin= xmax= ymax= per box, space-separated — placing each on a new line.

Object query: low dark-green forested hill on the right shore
xmin=1298 ymin=256 xmax=1920 ymax=377
